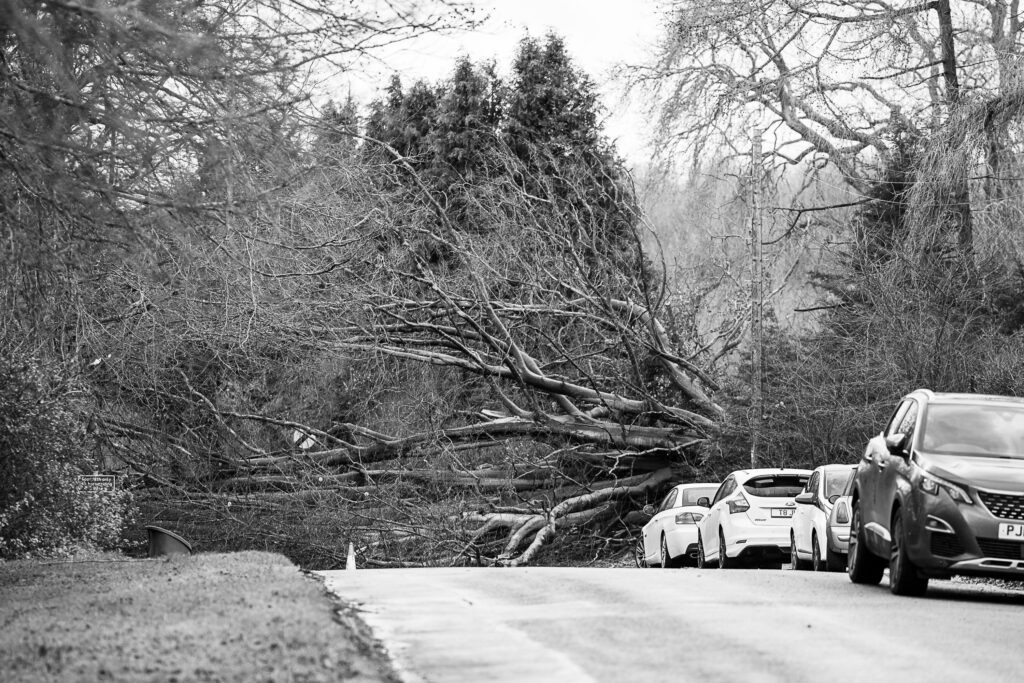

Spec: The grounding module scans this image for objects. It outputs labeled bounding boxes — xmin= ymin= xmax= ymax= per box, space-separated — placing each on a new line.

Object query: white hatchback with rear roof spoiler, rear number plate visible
xmin=697 ymin=469 xmax=811 ymax=568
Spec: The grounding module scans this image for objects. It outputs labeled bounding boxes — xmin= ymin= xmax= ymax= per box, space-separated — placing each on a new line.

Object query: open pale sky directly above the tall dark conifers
xmin=339 ymin=0 xmax=660 ymax=165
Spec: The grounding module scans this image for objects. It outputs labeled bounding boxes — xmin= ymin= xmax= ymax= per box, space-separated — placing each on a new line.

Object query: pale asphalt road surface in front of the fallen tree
xmin=322 ymin=567 xmax=1024 ymax=683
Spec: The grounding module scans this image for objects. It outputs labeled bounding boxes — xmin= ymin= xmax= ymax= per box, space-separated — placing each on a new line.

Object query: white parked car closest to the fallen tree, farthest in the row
xmin=635 ymin=483 xmax=718 ymax=567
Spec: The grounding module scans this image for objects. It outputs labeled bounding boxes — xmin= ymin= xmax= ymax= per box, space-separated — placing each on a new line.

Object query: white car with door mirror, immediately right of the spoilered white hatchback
xmin=790 ymin=465 xmax=854 ymax=571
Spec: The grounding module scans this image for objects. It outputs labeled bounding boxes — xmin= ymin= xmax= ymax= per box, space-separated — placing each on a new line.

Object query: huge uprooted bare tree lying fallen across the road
xmin=79 ymin=127 xmax=734 ymax=565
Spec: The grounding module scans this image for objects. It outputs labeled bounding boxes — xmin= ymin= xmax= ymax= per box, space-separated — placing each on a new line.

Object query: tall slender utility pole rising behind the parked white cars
xmin=751 ymin=128 xmax=764 ymax=469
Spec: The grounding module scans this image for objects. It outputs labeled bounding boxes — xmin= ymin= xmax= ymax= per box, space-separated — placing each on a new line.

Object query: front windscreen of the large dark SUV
xmin=921 ymin=403 xmax=1024 ymax=459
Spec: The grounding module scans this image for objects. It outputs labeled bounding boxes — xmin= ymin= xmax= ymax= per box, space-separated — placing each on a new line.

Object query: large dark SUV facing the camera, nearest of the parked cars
xmin=847 ymin=389 xmax=1024 ymax=595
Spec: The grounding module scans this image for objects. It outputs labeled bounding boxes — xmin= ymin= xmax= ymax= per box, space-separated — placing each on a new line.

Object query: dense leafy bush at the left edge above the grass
xmin=0 ymin=357 xmax=132 ymax=558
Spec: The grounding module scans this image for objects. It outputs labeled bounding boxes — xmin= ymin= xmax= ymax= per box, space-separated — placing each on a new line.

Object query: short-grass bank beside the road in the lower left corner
xmin=0 ymin=552 xmax=396 ymax=681
